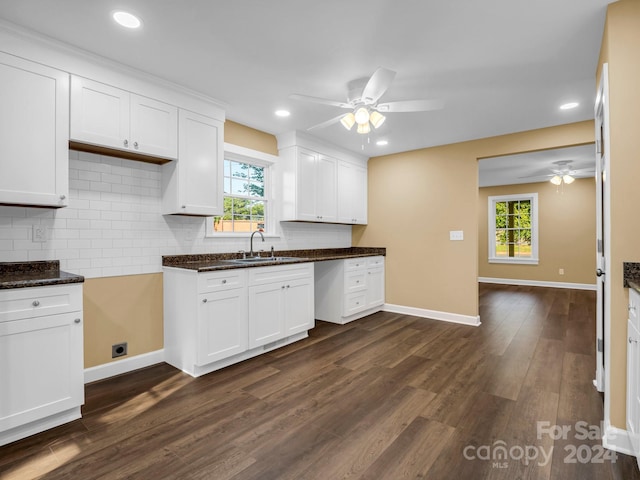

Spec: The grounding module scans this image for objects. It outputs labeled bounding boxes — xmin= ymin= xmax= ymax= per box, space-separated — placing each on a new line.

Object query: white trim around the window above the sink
xmin=205 ymin=142 xmax=280 ymax=238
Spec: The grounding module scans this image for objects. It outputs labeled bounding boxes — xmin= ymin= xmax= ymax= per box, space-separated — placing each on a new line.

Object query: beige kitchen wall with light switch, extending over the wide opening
xmin=353 ymin=121 xmax=594 ymax=316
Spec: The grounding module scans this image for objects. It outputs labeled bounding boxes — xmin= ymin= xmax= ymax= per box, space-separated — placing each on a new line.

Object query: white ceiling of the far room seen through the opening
xmin=478 ymin=143 xmax=596 ymax=187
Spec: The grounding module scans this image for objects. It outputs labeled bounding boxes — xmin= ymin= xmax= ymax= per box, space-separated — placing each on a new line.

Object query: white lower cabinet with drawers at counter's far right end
xmin=315 ymin=256 xmax=385 ymax=324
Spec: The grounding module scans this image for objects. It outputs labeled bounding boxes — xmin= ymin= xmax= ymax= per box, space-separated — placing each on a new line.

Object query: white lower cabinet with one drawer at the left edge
xmin=0 ymin=284 xmax=84 ymax=445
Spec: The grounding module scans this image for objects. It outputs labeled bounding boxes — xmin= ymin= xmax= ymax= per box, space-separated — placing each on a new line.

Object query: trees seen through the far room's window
xmin=495 ymin=200 xmax=531 ymax=258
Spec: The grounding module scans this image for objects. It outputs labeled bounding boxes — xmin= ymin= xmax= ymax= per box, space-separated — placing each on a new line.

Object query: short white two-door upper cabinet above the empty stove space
xmin=70 ymin=76 xmax=178 ymax=159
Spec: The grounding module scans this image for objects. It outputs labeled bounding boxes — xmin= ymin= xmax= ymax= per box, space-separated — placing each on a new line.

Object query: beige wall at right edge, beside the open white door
xmin=598 ymin=0 xmax=640 ymax=428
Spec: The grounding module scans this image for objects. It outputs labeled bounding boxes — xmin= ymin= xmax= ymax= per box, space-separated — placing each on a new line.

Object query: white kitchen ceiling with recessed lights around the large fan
xmin=0 ymin=0 xmax=609 ymax=156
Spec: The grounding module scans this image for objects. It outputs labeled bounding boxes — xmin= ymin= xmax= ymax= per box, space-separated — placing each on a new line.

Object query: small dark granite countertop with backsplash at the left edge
xmin=0 ymin=260 xmax=84 ymax=289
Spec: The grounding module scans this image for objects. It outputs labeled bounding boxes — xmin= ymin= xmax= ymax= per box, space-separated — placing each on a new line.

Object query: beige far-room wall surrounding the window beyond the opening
xmin=478 ymin=179 xmax=596 ymax=285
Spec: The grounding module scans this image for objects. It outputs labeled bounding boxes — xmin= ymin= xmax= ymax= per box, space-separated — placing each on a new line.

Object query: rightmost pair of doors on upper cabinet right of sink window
xmin=338 ymin=161 xmax=367 ymax=225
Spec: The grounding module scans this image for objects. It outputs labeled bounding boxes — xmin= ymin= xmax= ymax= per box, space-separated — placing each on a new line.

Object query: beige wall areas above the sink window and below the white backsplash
xmin=83 ymin=120 xmax=278 ymax=368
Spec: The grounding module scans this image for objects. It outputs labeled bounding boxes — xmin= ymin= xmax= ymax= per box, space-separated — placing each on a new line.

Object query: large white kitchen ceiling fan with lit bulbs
xmin=289 ymin=67 xmax=444 ymax=134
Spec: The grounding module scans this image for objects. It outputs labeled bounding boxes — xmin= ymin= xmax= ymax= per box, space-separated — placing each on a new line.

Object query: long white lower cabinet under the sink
xmin=163 ymin=263 xmax=314 ymax=377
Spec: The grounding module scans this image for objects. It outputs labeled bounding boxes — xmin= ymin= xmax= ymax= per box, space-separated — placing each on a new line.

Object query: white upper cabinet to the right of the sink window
xmin=278 ymin=132 xmax=367 ymax=224
